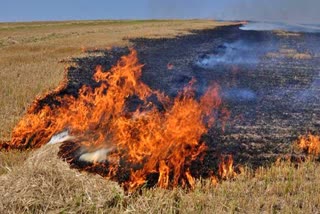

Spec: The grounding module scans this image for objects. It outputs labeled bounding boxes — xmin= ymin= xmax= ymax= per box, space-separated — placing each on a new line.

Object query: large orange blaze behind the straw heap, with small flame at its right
xmin=6 ymin=50 xmax=228 ymax=191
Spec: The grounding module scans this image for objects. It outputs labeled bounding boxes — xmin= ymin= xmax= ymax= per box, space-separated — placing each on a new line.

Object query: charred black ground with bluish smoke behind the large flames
xmin=24 ymin=26 xmax=320 ymax=167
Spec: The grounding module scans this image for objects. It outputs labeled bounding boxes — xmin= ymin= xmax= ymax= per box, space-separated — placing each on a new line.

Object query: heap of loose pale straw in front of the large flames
xmin=0 ymin=146 xmax=123 ymax=213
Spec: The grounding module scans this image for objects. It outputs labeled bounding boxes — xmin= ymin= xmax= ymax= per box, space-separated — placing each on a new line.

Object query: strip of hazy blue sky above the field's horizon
xmin=0 ymin=0 xmax=320 ymax=24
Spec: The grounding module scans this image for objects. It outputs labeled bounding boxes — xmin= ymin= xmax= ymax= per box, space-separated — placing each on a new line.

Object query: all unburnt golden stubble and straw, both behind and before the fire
xmin=0 ymin=20 xmax=320 ymax=213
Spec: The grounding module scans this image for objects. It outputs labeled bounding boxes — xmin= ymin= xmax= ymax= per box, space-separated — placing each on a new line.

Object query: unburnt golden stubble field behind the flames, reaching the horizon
xmin=0 ymin=20 xmax=232 ymax=140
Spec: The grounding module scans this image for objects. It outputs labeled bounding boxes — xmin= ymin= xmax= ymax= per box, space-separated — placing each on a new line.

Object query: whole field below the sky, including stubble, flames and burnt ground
xmin=0 ymin=20 xmax=320 ymax=213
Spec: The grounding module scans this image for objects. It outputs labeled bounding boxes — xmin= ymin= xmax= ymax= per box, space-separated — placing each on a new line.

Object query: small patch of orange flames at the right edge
xmin=297 ymin=134 xmax=320 ymax=156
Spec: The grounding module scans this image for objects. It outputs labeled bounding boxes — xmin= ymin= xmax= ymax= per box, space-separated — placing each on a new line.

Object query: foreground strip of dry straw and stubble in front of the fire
xmin=0 ymin=145 xmax=320 ymax=213
